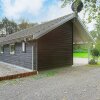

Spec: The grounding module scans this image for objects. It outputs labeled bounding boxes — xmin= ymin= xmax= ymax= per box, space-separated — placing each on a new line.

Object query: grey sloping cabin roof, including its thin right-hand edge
xmin=0 ymin=13 xmax=93 ymax=45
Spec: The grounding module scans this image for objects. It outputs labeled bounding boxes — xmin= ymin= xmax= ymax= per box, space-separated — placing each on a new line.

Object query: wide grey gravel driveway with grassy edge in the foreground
xmin=0 ymin=66 xmax=100 ymax=100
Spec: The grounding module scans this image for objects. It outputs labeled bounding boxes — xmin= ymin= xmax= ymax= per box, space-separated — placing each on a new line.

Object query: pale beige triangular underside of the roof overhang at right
xmin=73 ymin=17 xmax=95 ymax=44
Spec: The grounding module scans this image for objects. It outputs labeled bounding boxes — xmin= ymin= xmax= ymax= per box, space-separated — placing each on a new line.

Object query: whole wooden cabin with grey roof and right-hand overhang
xmin=0 ymin=13 xmax=93 ymax=71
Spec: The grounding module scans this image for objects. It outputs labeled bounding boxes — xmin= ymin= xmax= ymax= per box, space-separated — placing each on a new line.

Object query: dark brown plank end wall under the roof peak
xmin=38 ymin=21 xmax=73 ymax=70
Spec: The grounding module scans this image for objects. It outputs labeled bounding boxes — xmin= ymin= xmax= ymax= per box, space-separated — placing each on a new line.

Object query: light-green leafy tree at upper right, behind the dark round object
xmin=61 ymin=0 xmax=100 ymax=40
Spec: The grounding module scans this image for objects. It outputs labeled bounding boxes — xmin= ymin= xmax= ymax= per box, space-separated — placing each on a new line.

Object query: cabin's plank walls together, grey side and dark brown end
xmin=0 ymin=21 xmax=73 ymax=70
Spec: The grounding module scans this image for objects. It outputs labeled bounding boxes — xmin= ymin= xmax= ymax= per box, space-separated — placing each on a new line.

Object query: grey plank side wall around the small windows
xmin=0 ymin=42 xmax=32 ymax=69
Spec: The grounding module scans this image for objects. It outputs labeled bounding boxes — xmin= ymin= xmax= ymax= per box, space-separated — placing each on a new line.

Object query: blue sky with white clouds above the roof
xmin=0 ymin=0 xmax=95 ymax=29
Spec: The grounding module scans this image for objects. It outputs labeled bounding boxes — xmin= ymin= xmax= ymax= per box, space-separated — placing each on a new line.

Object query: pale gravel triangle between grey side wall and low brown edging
xmin=0 ymin=62 xmax=30 ymax=77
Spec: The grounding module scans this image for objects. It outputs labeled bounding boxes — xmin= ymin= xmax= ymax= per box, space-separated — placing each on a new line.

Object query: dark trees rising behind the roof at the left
xmin=0 ymin=17 xmax=37 ymax=34
